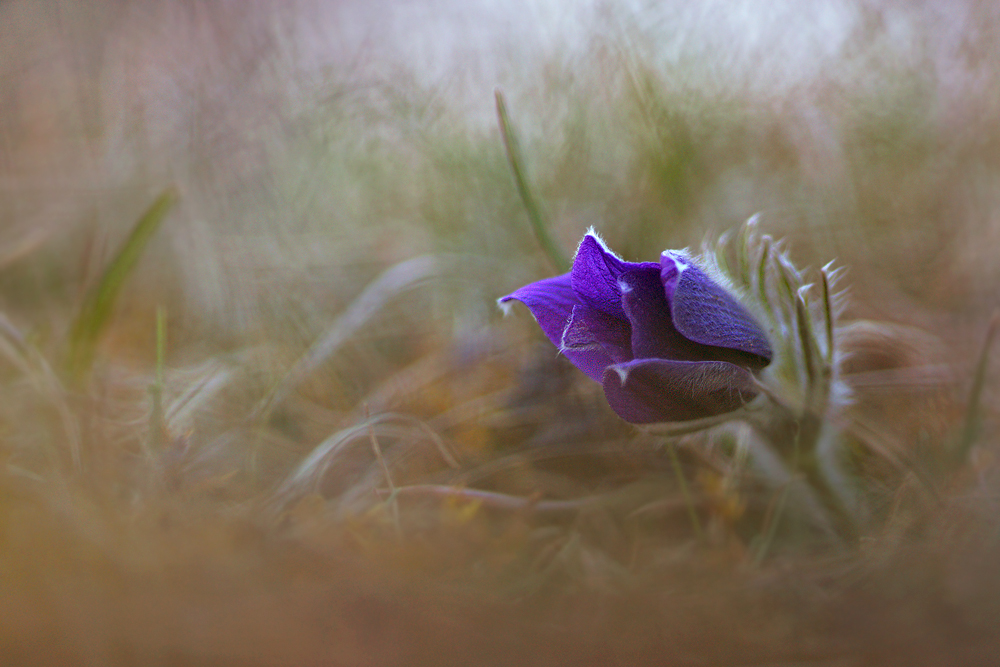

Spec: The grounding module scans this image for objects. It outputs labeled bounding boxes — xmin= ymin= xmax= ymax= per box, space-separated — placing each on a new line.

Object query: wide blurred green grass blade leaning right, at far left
xmin=66 ymin=188 xmax=177 ymax=386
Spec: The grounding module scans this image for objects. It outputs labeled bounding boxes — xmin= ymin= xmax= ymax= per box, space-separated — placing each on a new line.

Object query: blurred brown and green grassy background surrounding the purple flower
xmin=0 ymin=0 xmax=1000 ymax=665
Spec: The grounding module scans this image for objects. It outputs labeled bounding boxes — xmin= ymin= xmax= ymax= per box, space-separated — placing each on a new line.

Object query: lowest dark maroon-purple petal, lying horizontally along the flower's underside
xmin=601 ymin=359 xmax=757 ymax=424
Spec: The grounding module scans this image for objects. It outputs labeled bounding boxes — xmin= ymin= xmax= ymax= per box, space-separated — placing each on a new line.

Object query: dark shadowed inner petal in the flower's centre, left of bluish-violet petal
xmin=618 ymin=265 xmax=719 ymax=361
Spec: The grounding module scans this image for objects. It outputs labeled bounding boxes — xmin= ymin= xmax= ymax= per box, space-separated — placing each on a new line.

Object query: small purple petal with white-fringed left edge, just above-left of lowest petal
xmin=559 ymin=304 xmax=632 ymax=382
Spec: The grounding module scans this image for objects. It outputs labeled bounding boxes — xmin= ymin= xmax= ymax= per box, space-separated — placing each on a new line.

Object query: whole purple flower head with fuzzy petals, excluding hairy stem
xmin=500 ymin=232 xmax=772 ymax=424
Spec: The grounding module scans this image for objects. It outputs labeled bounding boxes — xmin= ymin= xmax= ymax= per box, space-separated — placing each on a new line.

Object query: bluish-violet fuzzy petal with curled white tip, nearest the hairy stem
xmin=660 ymin=250 xmax=773 ymax=370
